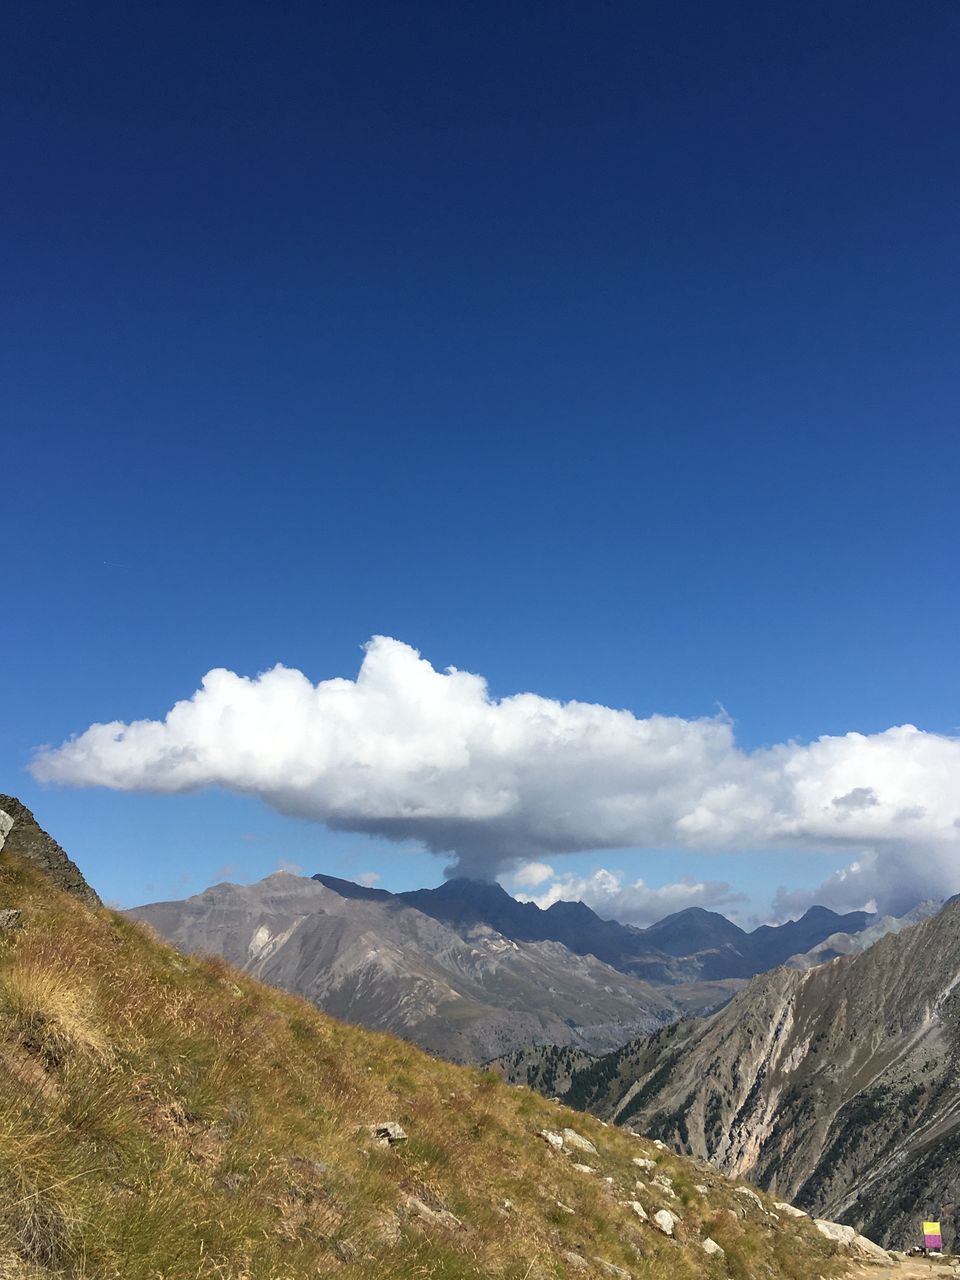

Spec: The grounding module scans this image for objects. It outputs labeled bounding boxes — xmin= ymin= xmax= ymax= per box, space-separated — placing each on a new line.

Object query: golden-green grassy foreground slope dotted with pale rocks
xmin=0 ymin=856 xmax=842 ymax=1280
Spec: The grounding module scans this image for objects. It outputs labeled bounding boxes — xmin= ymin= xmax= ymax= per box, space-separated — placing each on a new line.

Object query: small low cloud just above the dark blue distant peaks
xmin=517 ymin=868 xmax=746 ymax=925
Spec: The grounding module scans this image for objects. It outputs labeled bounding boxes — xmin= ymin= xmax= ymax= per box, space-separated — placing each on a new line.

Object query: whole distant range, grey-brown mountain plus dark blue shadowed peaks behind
xmin=131 ymin=873 xmax=890 ymax=1062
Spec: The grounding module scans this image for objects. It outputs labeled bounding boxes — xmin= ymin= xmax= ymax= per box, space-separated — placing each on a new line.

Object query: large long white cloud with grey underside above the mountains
xmin=32 ymin=636 xmax=960 ymax=906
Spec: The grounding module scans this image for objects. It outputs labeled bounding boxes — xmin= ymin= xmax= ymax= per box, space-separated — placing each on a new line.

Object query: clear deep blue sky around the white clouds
xmin=0 ymin=0 xmax=960 ymax=910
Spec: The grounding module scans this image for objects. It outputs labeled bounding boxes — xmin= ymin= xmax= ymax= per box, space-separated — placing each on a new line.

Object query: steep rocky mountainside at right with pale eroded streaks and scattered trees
xmin=497 ymin=901 xmax=960 ymax=1243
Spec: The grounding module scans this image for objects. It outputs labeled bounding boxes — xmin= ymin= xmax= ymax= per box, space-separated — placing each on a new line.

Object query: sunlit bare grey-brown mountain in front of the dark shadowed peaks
xmin=131 ymin=872 xmax=677 ymax=1061
